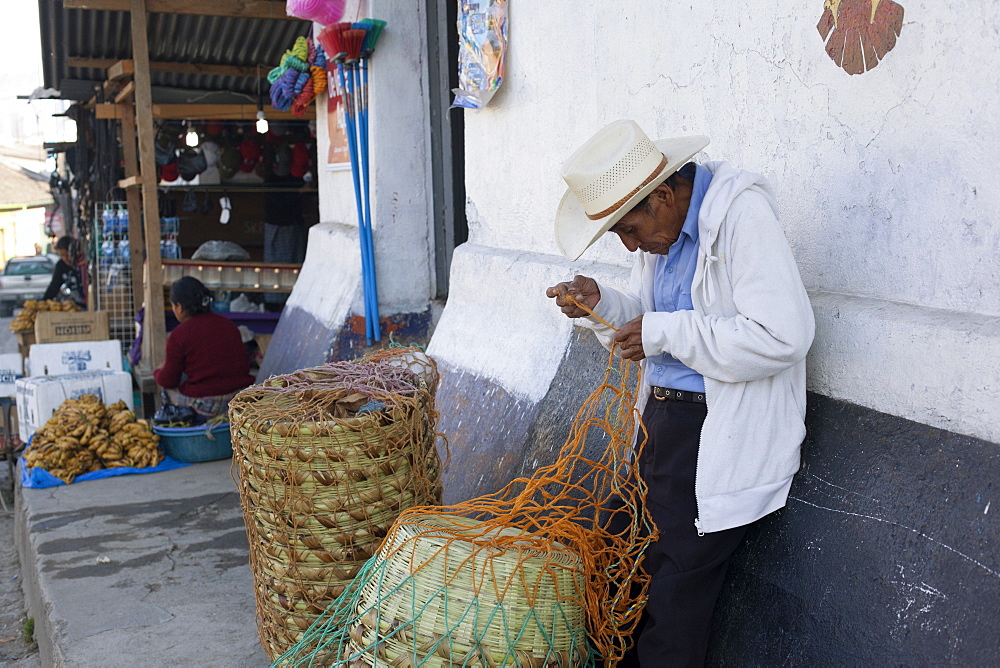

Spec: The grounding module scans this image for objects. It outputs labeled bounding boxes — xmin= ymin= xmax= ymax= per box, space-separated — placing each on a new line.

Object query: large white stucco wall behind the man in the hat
xmin=442 ymin=0 xmax=1000 ymax=441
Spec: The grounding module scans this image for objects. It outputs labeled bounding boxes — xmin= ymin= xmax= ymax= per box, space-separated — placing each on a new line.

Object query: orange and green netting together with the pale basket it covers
xmin=275 ymin=332 xmax=656 ymax=668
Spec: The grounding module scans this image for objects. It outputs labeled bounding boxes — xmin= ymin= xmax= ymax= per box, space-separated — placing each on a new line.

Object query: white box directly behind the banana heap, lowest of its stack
xmin=15 ymin=371 xmax=133 ymax=443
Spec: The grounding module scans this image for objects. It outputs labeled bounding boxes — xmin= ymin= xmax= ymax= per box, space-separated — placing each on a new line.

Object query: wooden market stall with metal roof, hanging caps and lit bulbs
xmin=40 ymin=0 xmax=318 ymax=410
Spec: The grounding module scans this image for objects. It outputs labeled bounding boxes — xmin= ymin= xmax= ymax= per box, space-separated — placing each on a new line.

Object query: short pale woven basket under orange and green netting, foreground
xmin=341 ymin=514 xmax=588 ymax=668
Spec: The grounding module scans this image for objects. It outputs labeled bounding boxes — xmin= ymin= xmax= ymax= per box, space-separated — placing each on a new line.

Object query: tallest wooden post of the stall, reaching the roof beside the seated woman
xmin=129 ymin=0 xmax=167 ymax=370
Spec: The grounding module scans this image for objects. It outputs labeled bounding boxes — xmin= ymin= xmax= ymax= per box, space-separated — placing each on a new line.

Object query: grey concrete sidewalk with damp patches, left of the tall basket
xmin=17 ymin=460 xmax=270 ymax=668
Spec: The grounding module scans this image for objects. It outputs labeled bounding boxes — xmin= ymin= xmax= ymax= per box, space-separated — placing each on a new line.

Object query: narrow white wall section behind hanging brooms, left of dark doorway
xmin=317 ymin=0 xmax=434 ymax=317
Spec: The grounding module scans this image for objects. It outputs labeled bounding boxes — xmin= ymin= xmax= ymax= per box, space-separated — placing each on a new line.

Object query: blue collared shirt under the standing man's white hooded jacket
xmin=646 ymin=165 xmax=712 ymax=392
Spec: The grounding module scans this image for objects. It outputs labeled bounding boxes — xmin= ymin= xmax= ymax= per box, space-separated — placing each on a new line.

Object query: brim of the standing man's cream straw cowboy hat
xmin=556 ymin=135 xmax=709 ymax=260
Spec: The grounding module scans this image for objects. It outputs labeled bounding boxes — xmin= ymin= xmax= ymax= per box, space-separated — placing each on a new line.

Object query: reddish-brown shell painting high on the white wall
xmin=816 ymin=0 xmax=903 ymax=74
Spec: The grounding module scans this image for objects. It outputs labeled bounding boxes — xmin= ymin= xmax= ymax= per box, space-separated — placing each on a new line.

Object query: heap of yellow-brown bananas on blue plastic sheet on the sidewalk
xmin=24 ymin=394 xmax=164 ymax=484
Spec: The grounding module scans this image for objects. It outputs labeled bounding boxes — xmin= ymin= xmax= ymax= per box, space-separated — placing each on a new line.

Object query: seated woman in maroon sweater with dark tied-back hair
xmin=153 ymin=276 xmax=254 ymax=419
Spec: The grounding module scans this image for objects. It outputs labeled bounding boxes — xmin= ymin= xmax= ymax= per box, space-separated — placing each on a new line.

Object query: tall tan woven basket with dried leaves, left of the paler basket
xmin=231 ymin=372 xmax=441 ymax=658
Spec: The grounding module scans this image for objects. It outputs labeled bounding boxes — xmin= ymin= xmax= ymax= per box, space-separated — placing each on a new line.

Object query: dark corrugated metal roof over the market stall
xmin=38 ymin=0 xmax=311 ymax=101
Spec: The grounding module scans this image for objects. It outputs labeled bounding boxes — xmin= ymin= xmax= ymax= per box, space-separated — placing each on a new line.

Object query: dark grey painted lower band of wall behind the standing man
xmin=438 ymin=329 xmax=1000 ymax=665
